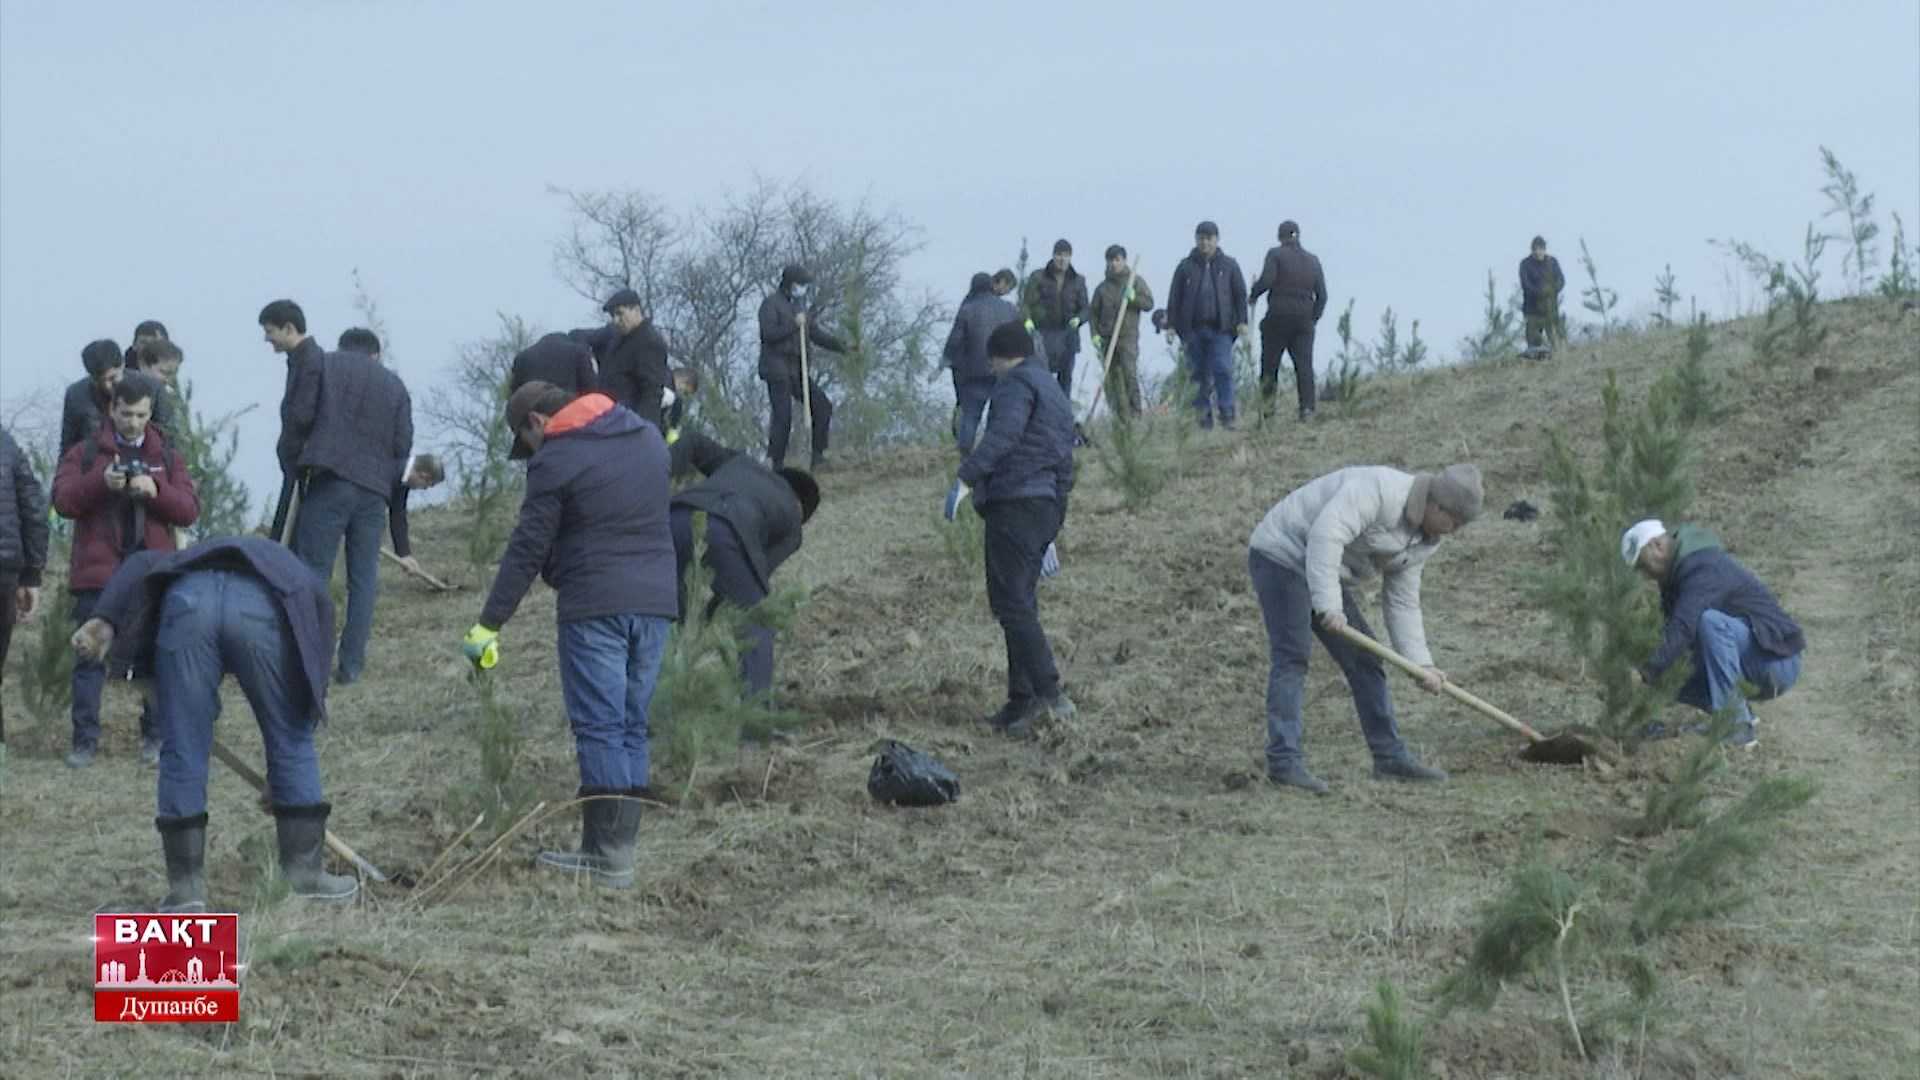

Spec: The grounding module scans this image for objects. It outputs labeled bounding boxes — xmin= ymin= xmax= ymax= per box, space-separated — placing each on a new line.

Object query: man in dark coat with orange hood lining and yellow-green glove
xmin=461 ymin=382 xmax=680 ymax=888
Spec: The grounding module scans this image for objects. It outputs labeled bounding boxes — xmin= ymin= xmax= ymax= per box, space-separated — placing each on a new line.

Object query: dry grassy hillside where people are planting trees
xmin=0 ymin=302 xmax=1920 ymax=1076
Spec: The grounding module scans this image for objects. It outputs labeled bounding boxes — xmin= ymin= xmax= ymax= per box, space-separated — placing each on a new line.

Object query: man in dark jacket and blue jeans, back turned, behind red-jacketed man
xmin=286 ymin=334 xmax=413 ymax=684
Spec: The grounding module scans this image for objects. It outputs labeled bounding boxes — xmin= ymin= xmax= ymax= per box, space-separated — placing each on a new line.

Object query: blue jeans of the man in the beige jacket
xmin=1246 ymin=552 xmax=1407 ymax=774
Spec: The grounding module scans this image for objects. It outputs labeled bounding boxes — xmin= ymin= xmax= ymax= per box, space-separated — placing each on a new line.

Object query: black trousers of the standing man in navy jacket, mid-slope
xmin=979 ymin=498 xmax=1062 ymax=707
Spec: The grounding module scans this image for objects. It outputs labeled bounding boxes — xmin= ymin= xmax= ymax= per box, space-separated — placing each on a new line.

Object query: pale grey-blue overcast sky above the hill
xmin=0 ymin=0 xmax=1920 ymax=500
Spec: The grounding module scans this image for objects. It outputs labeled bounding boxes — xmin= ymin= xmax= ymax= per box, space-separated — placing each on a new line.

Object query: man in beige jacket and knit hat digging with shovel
xmin=1246 ymin=465 xmax=1480 ymax=796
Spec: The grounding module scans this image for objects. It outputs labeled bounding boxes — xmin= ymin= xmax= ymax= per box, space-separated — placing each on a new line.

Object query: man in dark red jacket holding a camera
xmin=54 ymin=371 xmax=200 ymax=769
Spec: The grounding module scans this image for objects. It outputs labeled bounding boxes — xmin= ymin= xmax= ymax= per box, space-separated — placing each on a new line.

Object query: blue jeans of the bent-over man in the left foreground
xmin=154 ymin=571 xmax=324 ymax=819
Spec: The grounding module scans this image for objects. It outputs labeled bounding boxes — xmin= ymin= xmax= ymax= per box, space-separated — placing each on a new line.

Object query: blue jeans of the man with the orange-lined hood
xmin=559 ymin=615 xmax=672 ymax=792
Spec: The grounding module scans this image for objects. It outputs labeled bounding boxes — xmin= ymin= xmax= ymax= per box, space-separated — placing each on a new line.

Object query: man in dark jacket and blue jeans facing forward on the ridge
xmin=1167 ymin=221 xmax=1246 ymax=430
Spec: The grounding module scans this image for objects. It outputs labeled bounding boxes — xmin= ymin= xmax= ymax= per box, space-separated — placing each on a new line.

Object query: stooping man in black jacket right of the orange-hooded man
xmin=672 ymin=432 xmax=820 ymax=701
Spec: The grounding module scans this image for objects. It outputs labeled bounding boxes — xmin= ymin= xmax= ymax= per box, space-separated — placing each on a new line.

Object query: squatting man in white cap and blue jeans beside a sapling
xmin=1620 ymin=519 xmax=1807 ymax=749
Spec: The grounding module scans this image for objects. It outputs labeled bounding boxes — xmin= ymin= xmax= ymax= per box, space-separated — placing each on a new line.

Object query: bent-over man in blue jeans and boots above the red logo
xmin=73 ymin=536 xmax=359 ymax=911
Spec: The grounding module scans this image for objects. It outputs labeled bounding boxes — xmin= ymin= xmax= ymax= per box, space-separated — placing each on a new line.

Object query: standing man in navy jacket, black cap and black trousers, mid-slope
xmin=945 ymin=323 xmax=1073 ymax=738
